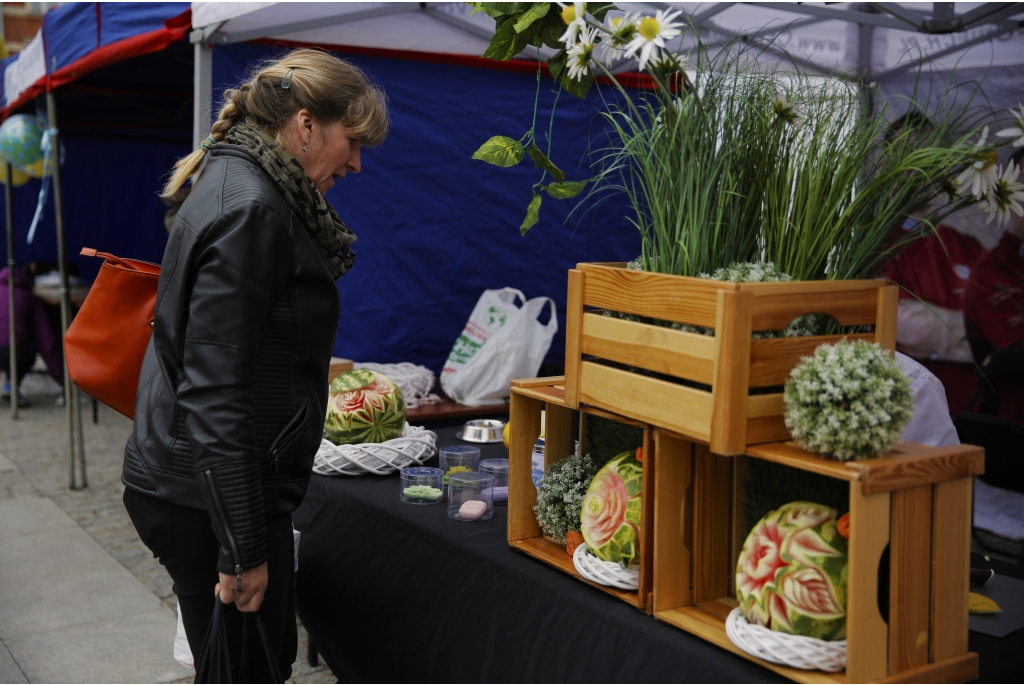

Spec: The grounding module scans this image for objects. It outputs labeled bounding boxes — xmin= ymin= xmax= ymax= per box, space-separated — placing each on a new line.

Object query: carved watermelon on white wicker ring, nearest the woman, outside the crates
xmin=324 ymin=369 xmax=406 ymax=444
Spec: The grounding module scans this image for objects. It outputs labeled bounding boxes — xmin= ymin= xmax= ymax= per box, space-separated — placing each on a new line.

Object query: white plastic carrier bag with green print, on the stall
xmin=441 ymin=288 xmax=558 ymax=406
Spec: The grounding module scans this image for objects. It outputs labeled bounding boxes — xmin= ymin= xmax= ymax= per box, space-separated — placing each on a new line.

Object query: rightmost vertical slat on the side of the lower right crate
xmin=931 ymin=478 xmax=973 ymax=661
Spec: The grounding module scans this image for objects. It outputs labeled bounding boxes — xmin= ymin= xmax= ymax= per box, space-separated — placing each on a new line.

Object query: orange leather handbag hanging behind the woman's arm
xmin=65 ymin=248 xmax=160 ymax=419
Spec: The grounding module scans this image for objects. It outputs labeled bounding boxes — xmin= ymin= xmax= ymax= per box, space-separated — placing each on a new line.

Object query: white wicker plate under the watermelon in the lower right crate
xmin=725 ymin=608 xmax=846 ymax=673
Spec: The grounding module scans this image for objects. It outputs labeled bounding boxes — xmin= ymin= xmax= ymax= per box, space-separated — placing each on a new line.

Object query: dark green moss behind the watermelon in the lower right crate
xmin=743 ymin=459 xmax=850 ymax=531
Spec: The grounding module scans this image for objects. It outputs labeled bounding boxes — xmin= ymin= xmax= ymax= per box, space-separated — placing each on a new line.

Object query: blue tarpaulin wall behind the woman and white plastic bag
xmin=213 ymin=44 xmax=640 ymax=372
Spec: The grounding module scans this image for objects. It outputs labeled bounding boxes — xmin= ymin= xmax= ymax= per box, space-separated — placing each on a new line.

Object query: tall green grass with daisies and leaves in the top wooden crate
xmin=473 ymin=2 xmax=1017 ymax=281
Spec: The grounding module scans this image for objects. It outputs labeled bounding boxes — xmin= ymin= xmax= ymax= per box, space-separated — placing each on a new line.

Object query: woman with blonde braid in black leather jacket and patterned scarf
xmin=122 ymin=50 xmax=388 ymax=682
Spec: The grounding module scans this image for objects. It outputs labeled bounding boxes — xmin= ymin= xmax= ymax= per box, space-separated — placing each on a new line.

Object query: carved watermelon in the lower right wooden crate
xmin=736 ymin=502 xmax=847 ymax=640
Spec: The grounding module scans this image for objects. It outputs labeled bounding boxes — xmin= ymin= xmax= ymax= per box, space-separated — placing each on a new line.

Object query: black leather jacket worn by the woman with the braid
xmin=121 ymin=144 xmax=339 ymax=573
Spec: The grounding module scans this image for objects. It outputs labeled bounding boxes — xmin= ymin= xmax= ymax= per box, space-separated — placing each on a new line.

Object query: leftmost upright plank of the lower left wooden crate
xmin=508 ymin=388 xmax=543 ymax=542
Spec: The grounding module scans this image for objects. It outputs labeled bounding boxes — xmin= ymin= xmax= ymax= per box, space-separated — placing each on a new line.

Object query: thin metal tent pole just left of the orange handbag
xmin=46 ymin=91 xmax=89 ymax=489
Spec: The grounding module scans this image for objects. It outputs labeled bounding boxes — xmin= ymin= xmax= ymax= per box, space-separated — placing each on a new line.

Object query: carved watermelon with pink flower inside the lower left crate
xmin=580 ymin=452 xmax=643 ymax=563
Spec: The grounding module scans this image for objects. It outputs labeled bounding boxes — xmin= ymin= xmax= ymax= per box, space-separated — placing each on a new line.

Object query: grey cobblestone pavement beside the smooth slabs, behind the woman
xmin=0 ymin=372 xmax=334 ymax=683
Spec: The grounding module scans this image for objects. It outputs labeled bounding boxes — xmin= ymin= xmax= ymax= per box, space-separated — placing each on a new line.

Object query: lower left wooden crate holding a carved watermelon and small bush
xmin=508 ymin=377 xmax=654 ymax=613
